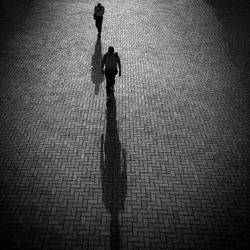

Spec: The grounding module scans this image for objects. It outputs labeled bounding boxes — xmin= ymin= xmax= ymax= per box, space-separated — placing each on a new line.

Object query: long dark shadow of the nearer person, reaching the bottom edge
xmin=101 ymin=99 xmax=127 ymax=250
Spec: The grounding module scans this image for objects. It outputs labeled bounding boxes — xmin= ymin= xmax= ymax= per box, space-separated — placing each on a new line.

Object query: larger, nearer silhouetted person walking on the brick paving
xmin=102 ymin=46 xmax=121 ymax=100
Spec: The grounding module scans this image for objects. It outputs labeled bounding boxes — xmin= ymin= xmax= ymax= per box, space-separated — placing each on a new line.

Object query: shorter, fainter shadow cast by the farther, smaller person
xmin=91 ymin=39 xmax=104 ymax=95
